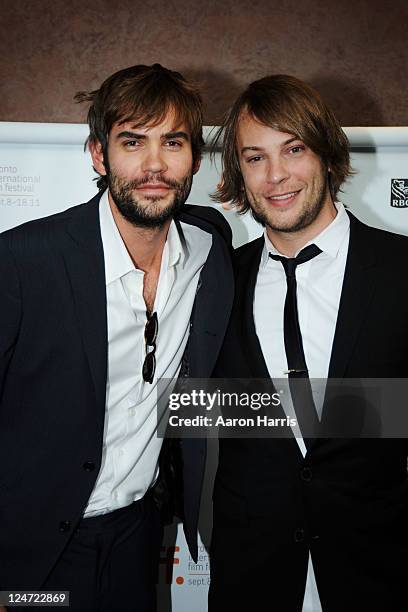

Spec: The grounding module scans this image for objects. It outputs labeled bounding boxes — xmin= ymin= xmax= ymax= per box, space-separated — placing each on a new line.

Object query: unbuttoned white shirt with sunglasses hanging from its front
xmin=85 ymin=191 xmax=212 ymax=517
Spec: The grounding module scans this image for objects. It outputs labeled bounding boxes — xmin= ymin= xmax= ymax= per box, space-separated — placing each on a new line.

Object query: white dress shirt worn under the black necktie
xmin=254 ymin=202 xmax=350 ymax=612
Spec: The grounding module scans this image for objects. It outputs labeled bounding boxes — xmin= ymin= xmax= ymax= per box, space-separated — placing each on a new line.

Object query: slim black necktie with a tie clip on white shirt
xmin=269 ymin=244 xmax=321 ymax=449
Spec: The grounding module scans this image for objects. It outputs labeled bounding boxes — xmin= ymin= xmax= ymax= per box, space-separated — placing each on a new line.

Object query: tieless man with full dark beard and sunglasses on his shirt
xmin=0 ymin=64 xmax=232 ymax=612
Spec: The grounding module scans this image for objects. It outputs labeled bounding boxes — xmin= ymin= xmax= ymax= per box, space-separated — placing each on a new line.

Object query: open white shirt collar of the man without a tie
xmin=99 ymin=190 xmax=186 ymax=285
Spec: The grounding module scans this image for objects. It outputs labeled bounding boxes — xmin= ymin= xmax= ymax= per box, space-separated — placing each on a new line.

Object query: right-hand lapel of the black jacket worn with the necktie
xmin=328 ymin=215 xmax=376 ymax=378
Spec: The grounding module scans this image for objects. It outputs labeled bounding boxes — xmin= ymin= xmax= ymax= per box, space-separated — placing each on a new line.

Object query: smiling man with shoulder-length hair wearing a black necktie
xmin=209 ymin=75 xmax=408 ymax=612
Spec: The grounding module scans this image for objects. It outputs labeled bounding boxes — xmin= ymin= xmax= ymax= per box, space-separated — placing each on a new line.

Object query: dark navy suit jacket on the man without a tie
xmin=0 ymin=196 xmax=233 ymax=589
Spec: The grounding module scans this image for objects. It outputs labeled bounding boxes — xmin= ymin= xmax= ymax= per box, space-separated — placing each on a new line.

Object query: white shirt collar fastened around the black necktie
xmin=261 ymin=202 xmax=350 ymax=266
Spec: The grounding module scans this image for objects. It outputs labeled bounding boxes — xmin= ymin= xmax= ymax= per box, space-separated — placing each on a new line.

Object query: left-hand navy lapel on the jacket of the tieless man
xmin=63 ymin=196 xmax=108 ymax=410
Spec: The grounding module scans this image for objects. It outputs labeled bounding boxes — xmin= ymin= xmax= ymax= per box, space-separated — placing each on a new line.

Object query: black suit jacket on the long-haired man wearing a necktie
xmin=210 ymin=215 xmax=408 ymax=612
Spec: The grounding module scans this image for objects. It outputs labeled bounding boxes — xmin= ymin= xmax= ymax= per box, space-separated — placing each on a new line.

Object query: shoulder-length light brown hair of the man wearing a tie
xmin=211 ymin=74 xmax=353 ymax=213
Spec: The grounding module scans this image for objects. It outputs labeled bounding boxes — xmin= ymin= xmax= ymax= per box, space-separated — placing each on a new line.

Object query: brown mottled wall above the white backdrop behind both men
xmin=0 ymin=0 xmax=408 ymax=125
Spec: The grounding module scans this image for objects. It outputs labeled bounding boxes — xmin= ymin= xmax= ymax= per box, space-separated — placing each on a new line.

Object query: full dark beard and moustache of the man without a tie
xmin=107 ymin=169 xmax=193 ymax=228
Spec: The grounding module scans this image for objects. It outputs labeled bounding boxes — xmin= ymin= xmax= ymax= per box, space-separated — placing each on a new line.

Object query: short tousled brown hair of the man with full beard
xmin=74 ymin=64 xmax=204 ymax=190
